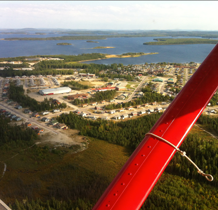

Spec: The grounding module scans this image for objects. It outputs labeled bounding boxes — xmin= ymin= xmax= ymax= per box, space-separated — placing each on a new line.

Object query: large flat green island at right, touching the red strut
xmin=143 ymin=38 xmax=218 ymax=45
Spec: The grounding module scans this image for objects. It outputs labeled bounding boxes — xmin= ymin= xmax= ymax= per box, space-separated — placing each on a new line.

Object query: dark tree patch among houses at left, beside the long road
xmin=9 ymin=82 xmax=67 ymax=112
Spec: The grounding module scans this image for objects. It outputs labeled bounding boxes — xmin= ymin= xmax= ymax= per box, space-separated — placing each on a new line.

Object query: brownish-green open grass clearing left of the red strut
xmin=0 ymin=135 xmax=129 ymax=202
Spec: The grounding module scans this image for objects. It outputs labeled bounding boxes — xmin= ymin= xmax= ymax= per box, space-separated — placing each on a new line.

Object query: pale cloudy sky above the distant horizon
xmin=0 ymin=1 xmax=218 ymax=31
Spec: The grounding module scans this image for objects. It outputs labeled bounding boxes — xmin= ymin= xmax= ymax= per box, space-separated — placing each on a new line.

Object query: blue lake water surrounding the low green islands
xmin=0 ymin=34 xmax=215 ymax=65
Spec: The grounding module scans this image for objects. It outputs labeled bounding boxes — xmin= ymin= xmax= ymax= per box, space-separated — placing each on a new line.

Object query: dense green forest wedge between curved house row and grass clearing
xmin=57 ymin=112 xmax=161 ymax=151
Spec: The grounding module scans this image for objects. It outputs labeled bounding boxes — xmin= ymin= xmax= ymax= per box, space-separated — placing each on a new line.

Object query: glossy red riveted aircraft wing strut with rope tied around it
xmin=93 ymin=45 xmax=218 ymax=210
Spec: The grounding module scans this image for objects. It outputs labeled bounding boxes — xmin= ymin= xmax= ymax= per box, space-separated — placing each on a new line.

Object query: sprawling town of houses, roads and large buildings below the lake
xmin=0 ymin=58 xmax=216 ymax=143
